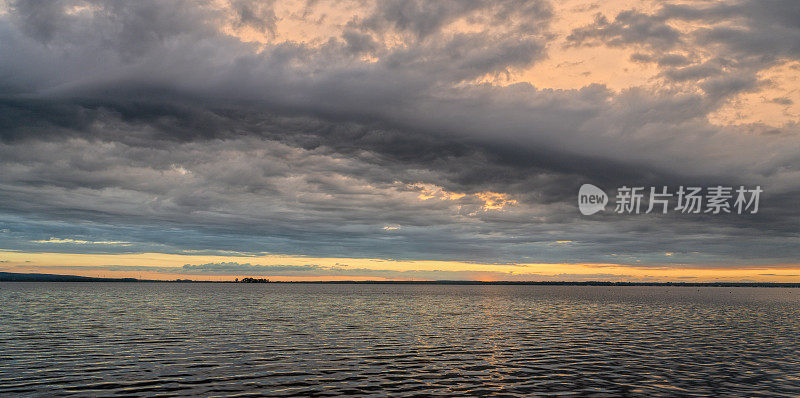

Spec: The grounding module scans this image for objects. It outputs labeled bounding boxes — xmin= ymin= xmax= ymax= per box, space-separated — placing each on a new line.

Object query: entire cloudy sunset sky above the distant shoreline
xmin=0 ymin=0 xmax=800 ymax=282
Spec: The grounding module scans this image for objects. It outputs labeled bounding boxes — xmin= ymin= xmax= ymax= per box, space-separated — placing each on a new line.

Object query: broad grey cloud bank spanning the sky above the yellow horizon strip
xmin=0 ymin=2 xmax=800 ymax=266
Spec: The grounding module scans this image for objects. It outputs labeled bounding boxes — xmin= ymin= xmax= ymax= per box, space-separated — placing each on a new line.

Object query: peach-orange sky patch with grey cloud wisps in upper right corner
xmin=568 ymin=0 xmax=800 ymax=101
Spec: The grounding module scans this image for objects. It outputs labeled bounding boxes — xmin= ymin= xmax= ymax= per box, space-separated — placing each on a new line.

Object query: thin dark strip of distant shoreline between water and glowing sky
xmin=0 ymin=272 xmax=800 ymax=288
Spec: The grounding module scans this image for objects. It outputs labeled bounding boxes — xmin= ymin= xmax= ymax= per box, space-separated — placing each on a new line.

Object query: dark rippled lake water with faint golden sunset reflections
xmin=0 ymin=283 xmax=800 ymax=396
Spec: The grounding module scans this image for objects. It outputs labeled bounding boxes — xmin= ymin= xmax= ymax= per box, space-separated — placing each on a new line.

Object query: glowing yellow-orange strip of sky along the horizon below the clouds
xmin=0 ymin=250 xmax=800 ymax=282
